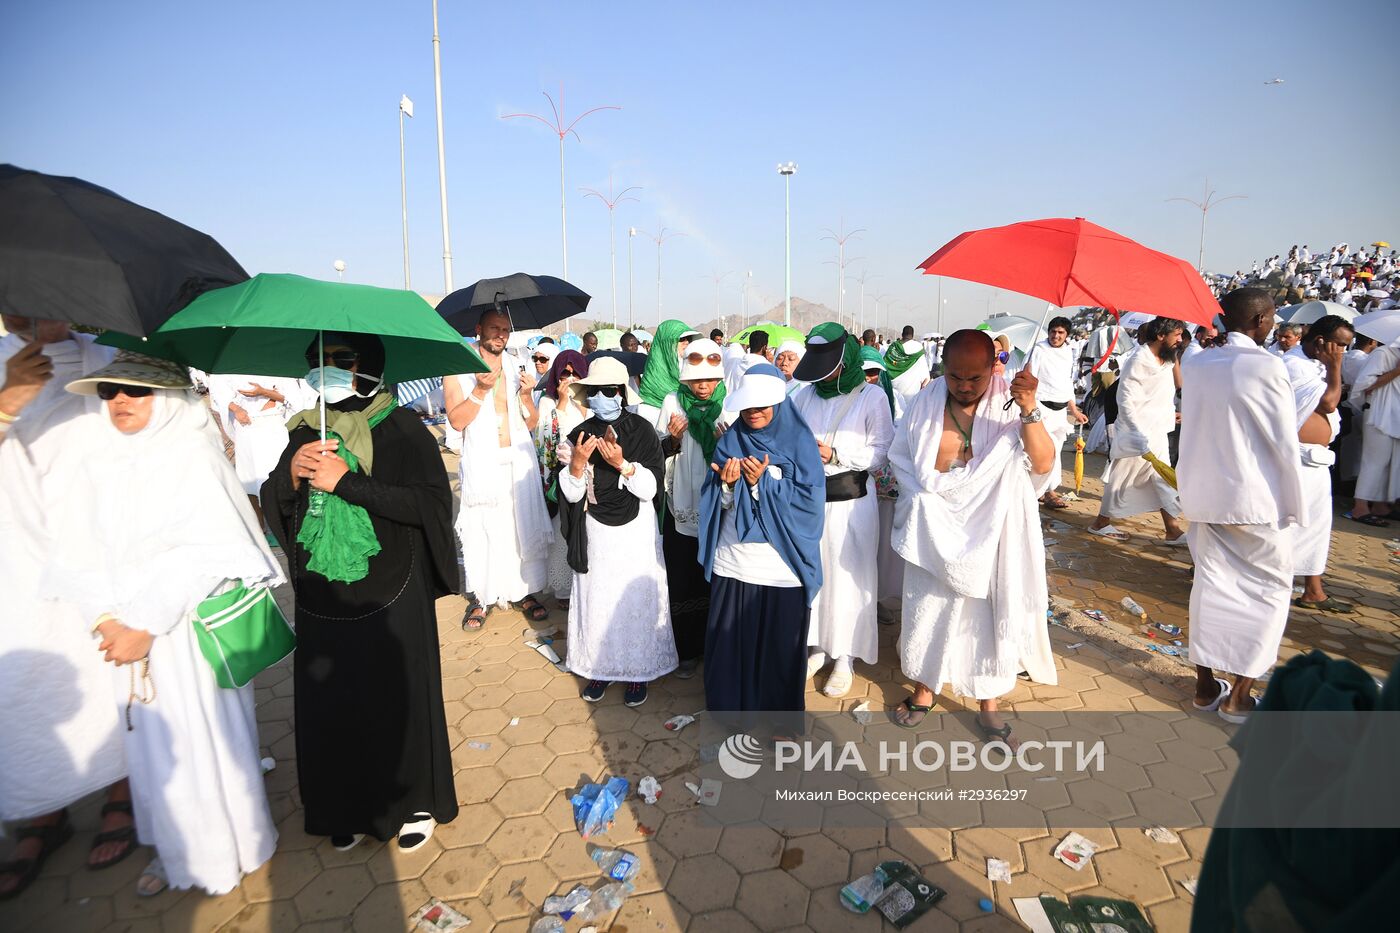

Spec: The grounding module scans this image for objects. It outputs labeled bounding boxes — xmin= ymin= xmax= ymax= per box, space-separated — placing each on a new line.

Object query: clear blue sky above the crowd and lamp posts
xmin=0 ymin=0 xmax=1400 ymax=329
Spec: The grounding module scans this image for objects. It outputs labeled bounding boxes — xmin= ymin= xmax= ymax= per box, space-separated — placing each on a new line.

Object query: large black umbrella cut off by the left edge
xmin=0 ymin=165 xmax=248 ymax=336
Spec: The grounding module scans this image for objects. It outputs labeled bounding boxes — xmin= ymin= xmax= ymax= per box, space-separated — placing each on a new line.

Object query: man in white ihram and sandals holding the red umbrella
xmin=889 ymin=331 xmax=1058 ymax=745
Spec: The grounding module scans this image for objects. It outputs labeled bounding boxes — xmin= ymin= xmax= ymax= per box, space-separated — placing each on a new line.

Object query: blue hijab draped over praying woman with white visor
xmin=700 ymin=366 xmax=826 ymax=605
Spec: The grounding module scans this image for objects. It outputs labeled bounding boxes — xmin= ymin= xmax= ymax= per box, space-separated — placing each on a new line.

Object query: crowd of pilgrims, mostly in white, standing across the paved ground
xmin=0 ymin=267 xmax=1383 ymax=898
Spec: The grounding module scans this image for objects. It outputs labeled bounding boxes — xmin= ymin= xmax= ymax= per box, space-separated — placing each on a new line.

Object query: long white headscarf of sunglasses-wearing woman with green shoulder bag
xmin=39 ymin=389 xmax=283 ymax=635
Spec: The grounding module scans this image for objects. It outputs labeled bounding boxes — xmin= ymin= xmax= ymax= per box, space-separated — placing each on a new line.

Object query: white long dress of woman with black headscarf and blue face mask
xmin=559 ymin=431 xmax=679 ymax=684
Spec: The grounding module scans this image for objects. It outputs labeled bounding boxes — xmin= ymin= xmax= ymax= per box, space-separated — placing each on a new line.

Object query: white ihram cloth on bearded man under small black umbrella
xmin=447 ymin=363 xmax=553 ymax=605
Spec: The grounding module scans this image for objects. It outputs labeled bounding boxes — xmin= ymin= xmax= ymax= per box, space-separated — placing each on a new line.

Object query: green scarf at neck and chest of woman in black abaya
xmin=287 ymin=392 xmax=399 ymax=583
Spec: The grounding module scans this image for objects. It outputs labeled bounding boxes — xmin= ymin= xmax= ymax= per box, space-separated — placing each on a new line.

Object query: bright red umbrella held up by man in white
xmin=918 ymin=217 xmax=1221 ymax=368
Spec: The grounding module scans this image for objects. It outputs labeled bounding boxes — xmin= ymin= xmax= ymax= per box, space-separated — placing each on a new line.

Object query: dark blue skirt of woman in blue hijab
xmin=704 ymin=574 xmax=811 ymax=712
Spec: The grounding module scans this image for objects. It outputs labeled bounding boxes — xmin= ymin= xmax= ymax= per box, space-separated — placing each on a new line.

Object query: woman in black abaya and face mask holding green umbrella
xmin=262 ymin=333 xmax=456 ymax=852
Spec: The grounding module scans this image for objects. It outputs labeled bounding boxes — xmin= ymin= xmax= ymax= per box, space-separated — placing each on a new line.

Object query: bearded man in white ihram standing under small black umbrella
xmin=442 ymin=308 xmax=553 ymax=630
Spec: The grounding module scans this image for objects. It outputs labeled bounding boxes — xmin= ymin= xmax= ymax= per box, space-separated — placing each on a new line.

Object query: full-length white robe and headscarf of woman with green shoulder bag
xmin=39 ymin=389 xmax=283 ymax=894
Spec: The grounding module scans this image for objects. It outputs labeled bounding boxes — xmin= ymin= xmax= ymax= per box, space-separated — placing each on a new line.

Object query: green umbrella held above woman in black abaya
xmin=98 ymin=273 xmax=487 ymax=382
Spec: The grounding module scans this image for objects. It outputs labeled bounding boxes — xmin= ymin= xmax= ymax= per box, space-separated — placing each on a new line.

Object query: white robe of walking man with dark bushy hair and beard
xmin=1099 ymin=345 xmax=1182 ymax=518
